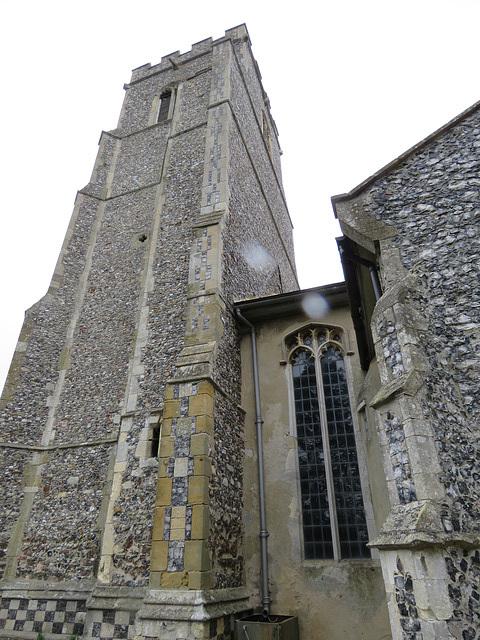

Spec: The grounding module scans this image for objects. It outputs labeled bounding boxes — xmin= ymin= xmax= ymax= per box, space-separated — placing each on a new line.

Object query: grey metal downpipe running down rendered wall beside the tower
xmin=235 ymin=309 xmax=271 ymax=617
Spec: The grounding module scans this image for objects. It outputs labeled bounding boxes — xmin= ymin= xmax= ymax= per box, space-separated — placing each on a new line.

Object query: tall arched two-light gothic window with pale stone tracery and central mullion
xmin=286 ymin=327 xmax=370 ymax=559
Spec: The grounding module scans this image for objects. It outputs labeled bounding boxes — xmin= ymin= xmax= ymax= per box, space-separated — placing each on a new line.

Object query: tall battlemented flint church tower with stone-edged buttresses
xmin=0 ymin=25 xmax=298 ymax=639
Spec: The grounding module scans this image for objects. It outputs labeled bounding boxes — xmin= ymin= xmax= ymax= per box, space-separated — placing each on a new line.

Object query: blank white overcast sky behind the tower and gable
xmin=0 ymin=0 xmax=480 ymax=388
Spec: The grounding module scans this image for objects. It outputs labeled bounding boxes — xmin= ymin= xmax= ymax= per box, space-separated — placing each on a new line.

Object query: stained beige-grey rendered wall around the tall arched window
xmin=240 ymin=294 xmax=390 ymax=640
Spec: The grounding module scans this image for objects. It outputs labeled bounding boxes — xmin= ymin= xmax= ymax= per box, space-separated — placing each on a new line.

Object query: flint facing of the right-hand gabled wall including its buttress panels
xmin=354 ymin=108 xmax=480 ymax=640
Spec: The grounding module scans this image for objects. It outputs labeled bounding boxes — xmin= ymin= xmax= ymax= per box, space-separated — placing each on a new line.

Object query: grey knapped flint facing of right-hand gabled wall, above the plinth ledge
xmin=366 ymin=111 xmax=480 ymax=532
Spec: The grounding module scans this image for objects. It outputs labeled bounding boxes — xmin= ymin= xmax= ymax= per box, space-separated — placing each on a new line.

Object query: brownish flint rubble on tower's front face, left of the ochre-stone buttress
xmin=0 ymin=48 xmax=209 ymax=586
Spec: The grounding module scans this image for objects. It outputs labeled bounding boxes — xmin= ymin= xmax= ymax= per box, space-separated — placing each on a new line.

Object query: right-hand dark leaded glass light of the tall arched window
xmin=321 ymin=347 xmax=370 ymax=558
